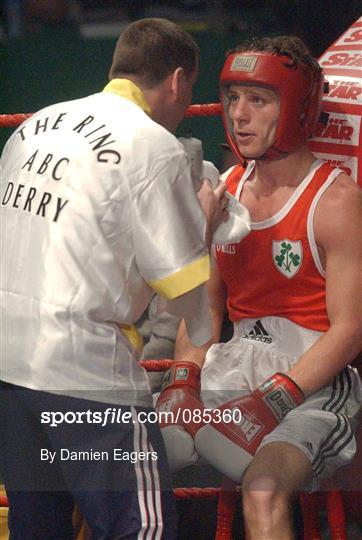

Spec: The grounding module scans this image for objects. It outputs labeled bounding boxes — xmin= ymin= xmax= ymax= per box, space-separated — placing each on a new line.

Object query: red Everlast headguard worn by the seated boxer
xmin=220 ymin=51 xmax=324 ymax=160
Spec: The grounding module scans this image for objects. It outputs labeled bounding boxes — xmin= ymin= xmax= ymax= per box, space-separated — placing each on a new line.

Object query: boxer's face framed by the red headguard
xmin=227 ymin=84 xmax=279 ymax=158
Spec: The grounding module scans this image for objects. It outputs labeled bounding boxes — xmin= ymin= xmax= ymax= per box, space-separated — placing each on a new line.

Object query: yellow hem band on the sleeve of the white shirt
xmin=149 ymin=254 xmax=210 ymax=300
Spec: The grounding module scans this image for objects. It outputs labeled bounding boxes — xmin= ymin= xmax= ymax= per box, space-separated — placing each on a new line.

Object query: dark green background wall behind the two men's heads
xmin=0 ymin=27 xmax=242 ymax=164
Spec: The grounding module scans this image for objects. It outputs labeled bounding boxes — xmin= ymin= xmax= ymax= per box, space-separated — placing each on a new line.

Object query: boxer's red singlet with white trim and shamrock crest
xmin=216 ymin=161 xmax=342 ymax=332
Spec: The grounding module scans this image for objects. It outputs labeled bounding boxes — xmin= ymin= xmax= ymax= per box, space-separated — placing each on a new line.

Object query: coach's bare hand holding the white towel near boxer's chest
xmin=197 ymin=179 xmax=229 ymax=249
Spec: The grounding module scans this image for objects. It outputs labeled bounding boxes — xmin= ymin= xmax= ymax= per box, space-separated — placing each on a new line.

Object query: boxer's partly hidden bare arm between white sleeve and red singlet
xmin=175 ymin=266 xmax=226 ymax=367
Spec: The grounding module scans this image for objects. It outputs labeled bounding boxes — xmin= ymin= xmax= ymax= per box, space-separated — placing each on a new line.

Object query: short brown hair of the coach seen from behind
xmin=109 ymin=18 xmax=199 ymax=88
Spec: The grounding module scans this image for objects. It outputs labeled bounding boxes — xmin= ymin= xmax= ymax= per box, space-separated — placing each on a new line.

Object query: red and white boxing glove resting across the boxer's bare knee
xmin=195 ymin=373 xmax=304 ymax=482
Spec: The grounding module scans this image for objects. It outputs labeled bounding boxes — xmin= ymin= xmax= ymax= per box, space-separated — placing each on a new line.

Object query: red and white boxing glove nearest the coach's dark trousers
xmin=156 ymin=361 xmax=204 ymax=470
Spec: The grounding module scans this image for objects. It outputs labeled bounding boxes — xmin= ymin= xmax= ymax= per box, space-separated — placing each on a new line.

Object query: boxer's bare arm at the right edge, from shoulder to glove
xmin=288 ymin=174 xmax=362 ymax=395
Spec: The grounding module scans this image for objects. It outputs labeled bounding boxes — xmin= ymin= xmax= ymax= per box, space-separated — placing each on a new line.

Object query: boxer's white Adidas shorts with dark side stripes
xmin=201 ymin=317 xmax=362 ymax=487
